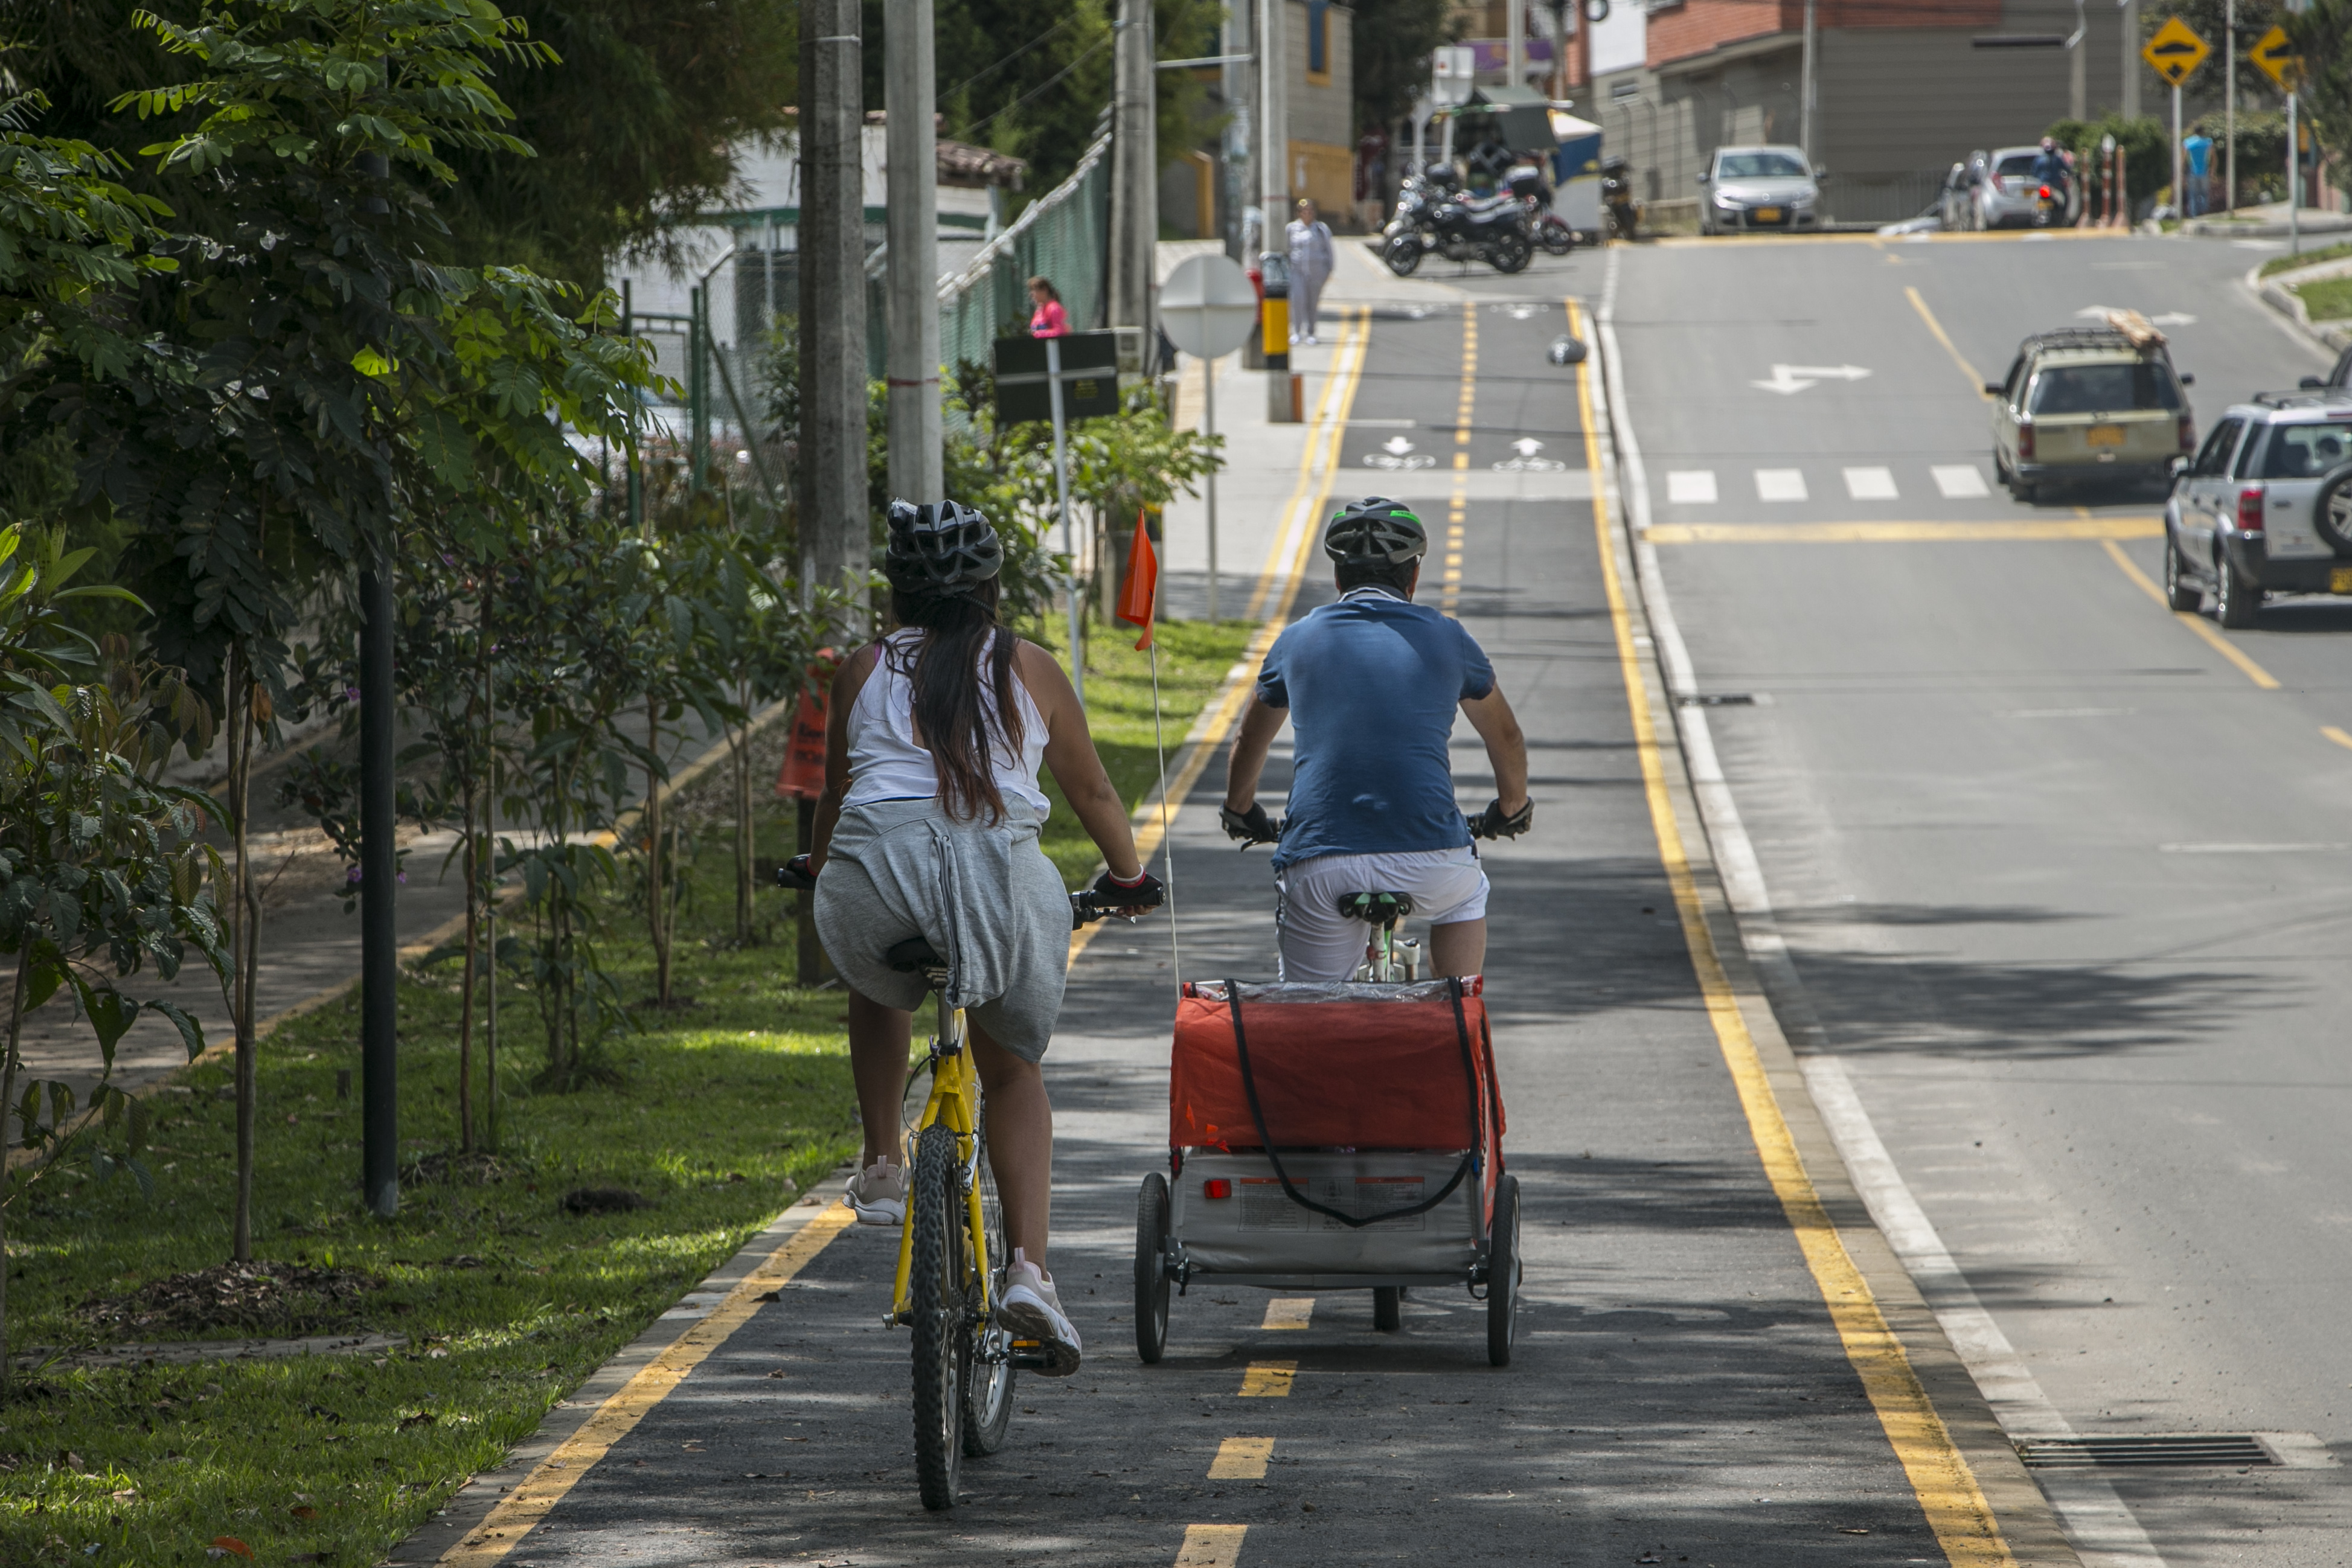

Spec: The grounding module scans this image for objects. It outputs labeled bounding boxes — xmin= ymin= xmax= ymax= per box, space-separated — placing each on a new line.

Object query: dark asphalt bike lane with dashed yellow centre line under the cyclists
xmin=414 ymin=298 xmax=2069 ymax=1568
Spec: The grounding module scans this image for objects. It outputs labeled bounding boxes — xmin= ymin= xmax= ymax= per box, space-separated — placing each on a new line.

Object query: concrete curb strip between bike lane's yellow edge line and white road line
xmin=1595 ymin=255 xmax=2084 ymax=1568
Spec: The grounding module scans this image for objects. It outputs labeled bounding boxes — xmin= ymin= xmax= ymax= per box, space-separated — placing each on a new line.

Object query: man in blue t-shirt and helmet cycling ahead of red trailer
xmin=1221 ymin=496 xmax=1536 ymax=983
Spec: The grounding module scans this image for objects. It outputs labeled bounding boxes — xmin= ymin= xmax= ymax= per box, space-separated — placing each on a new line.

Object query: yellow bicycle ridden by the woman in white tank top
xmin=885 ymin=894 xmax=1110 ymax=1509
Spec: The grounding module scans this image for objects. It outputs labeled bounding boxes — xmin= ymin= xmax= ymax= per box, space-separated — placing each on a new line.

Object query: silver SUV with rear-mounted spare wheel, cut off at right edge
xmin=2164 ymin=388 xmax=2352 ymax=628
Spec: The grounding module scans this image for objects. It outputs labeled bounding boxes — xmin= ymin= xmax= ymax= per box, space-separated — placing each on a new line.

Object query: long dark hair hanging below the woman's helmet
xmin=882 ymin=578 xmax=1023 ymax=823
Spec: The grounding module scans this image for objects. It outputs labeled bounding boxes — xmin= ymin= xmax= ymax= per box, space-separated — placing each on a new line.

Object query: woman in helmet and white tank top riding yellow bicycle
xmin=809 ymin=501 xmax=1162 ymax=1375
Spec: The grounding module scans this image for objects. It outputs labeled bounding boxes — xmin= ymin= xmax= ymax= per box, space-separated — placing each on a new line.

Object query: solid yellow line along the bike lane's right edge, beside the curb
xmin=1569 ymin=306 xmax=2016 ymax=1568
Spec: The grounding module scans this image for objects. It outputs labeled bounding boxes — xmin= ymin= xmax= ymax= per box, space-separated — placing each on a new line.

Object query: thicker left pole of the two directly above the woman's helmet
xmin=799 ymin=0 xmax=870 ymax=635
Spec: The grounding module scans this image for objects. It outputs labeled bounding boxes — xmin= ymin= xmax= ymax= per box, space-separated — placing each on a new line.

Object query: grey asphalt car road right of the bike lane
xmin=1613 ymin=226 xmax=2352 ymax=1568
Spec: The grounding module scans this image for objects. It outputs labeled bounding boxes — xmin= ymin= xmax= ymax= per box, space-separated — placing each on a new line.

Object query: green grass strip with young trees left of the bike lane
xmin=0 ymin=606 xmax=1249 ymax=1566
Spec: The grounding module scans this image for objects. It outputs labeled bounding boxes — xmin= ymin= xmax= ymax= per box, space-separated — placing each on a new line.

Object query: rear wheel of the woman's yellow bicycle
xmin=906 ymin=1126 xmax=972 ymax=1509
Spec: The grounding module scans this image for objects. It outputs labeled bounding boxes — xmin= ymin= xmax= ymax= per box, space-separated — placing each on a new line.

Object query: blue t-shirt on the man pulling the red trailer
xmin=1258 ymin=590 xmax=1493 ymax=870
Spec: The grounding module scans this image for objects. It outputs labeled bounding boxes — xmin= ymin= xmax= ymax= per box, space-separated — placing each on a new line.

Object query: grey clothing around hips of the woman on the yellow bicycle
xmin=816 ymin=799 xmax=1070 ymax=1063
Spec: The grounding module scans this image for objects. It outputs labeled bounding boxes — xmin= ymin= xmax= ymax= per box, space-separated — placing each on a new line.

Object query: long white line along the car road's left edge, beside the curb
xmin=1595 ymin=249 xmax=2166 ymax=1568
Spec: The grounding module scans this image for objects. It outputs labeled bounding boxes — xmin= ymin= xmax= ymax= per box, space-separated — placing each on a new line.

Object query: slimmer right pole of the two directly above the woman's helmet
xmin=884 ymin=0 xmax=946 ymax=505
